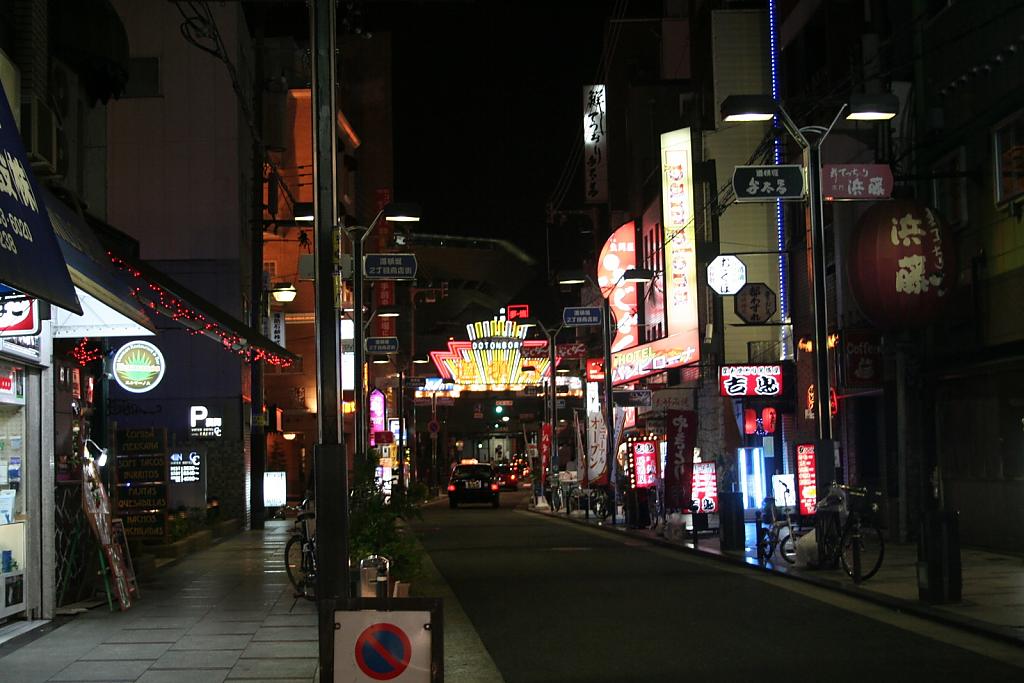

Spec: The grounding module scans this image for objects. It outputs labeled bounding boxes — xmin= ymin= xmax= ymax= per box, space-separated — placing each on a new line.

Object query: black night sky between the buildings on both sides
xmin=380 ymin=0 xmax=612 ymax=269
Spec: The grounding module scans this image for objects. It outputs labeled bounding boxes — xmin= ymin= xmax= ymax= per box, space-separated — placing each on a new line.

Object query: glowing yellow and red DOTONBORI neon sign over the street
xmin=430 ymin=316 xmax=557 ymax=391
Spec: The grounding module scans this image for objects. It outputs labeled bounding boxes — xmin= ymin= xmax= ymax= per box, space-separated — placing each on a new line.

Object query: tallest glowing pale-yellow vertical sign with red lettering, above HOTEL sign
xmin=662 ymin=128 xmax=699 ymax=339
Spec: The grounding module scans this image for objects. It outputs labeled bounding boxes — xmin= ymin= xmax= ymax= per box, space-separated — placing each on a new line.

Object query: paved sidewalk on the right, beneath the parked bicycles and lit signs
xmin=535 ymin=501 xmax=1024 ymax=645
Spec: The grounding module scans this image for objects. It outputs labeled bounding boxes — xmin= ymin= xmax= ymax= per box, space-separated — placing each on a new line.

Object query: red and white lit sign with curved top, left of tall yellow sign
xmin=597 ymin=220 xmax=639 ymax=356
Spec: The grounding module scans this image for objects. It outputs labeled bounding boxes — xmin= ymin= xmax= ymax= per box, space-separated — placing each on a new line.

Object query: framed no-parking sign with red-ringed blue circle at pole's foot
xmin=334 ymin=598 xmax=443 ymax=683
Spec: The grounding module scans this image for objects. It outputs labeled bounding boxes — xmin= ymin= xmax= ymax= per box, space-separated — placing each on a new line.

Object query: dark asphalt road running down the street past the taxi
xmin=414 ymin=494 xmax=1024 ymax=683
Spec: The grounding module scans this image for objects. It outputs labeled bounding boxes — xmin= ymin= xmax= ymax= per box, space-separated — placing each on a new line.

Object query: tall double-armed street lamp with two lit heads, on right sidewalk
xmin=722 ymin=93 xmax=899 ymax=450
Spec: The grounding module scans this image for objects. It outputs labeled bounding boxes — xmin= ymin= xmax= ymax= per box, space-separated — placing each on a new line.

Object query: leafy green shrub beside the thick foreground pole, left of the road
xmin=348 ymin=451 xmax=424 ymax=582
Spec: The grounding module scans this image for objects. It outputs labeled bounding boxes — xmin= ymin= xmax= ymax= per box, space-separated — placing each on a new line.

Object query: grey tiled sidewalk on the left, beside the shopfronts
xmin=0 ymin=522 xmax=317 ymax=683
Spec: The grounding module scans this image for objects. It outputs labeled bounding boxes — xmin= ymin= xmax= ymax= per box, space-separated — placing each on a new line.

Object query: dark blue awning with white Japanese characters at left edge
xmin=0 ymin=86 xmax=82 ymax=315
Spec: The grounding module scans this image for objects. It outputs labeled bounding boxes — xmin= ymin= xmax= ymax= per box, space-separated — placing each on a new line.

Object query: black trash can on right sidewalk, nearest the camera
xmin=918 ymin=510 xmax=964 ymax=604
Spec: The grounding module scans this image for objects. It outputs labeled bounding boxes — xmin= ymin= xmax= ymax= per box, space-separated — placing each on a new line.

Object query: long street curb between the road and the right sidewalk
xmin=520 ymin=506 xmax=1024 ymax=647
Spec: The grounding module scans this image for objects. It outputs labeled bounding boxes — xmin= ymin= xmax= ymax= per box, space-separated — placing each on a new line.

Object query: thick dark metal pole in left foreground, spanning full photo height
xmin=309 ymin=0 xmax=346 ymax=683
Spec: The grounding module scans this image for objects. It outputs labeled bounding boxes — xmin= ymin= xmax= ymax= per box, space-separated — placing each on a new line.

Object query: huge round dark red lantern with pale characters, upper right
xmin=848 ymin=200 xmax=956 ymax=330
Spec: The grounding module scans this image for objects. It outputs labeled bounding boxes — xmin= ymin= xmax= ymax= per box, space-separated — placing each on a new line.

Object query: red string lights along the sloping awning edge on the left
xmin=109 ymin=253 xmax=293 ymax=368
